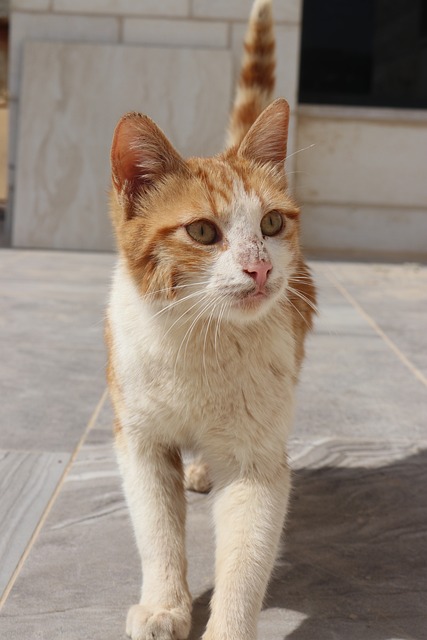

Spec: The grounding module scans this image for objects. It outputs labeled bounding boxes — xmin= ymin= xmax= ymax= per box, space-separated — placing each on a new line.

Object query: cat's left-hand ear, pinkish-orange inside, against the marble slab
xmin=111 ymin=113 xmax=188 ymax=214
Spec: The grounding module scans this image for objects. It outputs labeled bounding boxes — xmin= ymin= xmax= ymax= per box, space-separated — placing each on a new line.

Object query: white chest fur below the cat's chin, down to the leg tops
xmin=109 ymin=264 xmax=295 ymax=458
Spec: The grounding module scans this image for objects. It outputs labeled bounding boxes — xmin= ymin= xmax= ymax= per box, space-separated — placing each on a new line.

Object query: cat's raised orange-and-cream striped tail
xmin=226 ymin=0 xmax=276 ymax=148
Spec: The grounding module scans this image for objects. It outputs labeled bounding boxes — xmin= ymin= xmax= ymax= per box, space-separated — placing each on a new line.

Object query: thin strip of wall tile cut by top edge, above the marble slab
xmin=53 ymin=0 xmax=189 ymax=16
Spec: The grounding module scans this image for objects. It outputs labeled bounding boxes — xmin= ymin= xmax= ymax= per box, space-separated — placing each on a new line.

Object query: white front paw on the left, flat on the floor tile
xmin=126 ymin=604 xmax=191 ymax=640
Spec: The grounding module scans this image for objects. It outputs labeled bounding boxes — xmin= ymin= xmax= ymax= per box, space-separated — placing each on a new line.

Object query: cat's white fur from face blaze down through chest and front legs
xmin=108 ymin=202 xmax=297 ymax=640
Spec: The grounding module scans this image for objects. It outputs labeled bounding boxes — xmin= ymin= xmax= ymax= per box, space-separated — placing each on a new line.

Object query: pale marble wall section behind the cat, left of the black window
xmin=8 ymin=0 xmax=301 ymax=250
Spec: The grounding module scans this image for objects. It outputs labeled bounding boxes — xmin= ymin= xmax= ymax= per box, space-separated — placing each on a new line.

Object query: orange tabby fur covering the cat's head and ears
xmin=111 ymin=101 xmax=315 ymax=335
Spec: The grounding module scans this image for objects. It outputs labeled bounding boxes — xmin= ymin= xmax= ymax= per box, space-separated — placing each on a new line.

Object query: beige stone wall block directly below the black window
xmin=297 ymin=115 xmax=427 ymax=208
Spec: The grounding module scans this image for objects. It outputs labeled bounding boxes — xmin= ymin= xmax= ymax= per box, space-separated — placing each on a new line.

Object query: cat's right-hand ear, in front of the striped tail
xmin=237 ymin=98 xmax=289 ymax=170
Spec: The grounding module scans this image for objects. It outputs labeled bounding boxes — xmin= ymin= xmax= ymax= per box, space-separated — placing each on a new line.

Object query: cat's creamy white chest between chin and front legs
xmin=109 ymin=264 xmax=295 ymax=436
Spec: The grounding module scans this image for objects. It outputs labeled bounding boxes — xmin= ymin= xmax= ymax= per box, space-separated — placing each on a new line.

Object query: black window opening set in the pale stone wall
xmin=299 ymin=0 xmax=427 ymax=109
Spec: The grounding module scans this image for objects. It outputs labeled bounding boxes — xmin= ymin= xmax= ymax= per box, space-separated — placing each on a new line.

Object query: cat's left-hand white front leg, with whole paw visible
xmin=117 ymin=433 xmax=191 ymax=640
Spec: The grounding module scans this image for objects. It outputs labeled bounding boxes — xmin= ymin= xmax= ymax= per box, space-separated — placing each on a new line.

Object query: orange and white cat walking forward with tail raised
xmin=105 ymin=0 xmax=315 ymax=640
